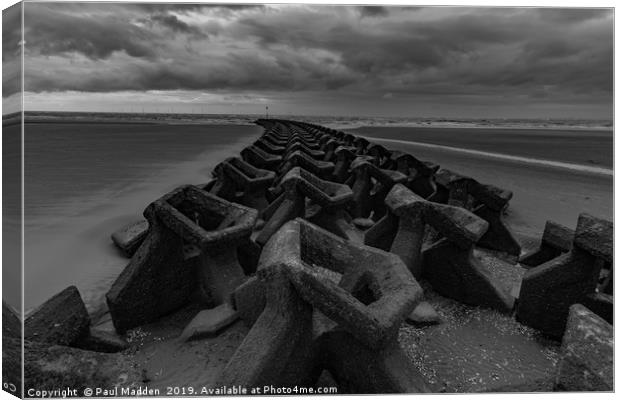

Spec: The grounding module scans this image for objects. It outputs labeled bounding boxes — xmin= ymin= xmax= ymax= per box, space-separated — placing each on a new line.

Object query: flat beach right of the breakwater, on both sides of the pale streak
xmin=352 ymin=128 xmax=613 ymax=238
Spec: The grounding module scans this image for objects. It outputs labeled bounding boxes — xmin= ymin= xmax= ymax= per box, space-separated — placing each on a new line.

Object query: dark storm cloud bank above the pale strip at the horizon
xmin=14 ymin=4 xmax=613 ymax=111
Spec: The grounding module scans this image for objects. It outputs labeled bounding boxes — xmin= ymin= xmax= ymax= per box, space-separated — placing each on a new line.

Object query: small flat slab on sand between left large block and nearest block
xmin=180 ymin=303 xmax=239 ymax=341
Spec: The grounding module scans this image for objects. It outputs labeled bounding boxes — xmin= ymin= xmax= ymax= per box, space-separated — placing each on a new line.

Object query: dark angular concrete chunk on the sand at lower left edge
xmin=24 ymin=286 xmax=90 ymax=346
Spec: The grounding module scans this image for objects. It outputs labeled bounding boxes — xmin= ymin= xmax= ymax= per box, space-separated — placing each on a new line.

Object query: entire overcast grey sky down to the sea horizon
xmin=3 ymin=3 xmax=613 ymax=118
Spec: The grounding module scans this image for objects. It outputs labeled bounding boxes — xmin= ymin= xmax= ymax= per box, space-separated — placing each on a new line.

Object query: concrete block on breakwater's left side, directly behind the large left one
xmin=210 ymin=157 xmax=276 ymax=212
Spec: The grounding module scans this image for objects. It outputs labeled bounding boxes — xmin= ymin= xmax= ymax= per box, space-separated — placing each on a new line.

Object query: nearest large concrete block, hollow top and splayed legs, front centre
xmin=225 ymin=219 xmax=429 ymax=393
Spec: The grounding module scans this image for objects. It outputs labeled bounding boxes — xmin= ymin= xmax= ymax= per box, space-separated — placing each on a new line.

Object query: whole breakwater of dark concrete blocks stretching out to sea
xmin=7 ymin=120 xmax=613 ymax=393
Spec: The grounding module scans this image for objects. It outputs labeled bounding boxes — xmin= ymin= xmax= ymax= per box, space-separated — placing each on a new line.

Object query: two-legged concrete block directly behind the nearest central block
xmin=256 ymin=167 xmax=353 ymax=246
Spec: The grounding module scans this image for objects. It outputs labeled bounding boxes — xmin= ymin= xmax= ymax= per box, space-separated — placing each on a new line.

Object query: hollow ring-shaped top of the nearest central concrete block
xmin=259 ymin=219 xmax=422 ymax=348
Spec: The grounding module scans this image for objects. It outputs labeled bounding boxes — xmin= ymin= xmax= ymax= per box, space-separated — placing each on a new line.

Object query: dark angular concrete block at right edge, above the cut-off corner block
xmin=517 ymin=213 xmax=613 ymax=338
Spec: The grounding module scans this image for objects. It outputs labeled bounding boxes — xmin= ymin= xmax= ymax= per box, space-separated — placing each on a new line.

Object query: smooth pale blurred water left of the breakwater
xmin=24 ymin=123 xmax=262 ymax=311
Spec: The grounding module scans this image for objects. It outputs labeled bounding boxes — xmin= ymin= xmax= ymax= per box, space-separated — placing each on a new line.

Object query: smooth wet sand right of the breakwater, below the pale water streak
xmin=360 ymin=131 xmax=613 ymax=238
